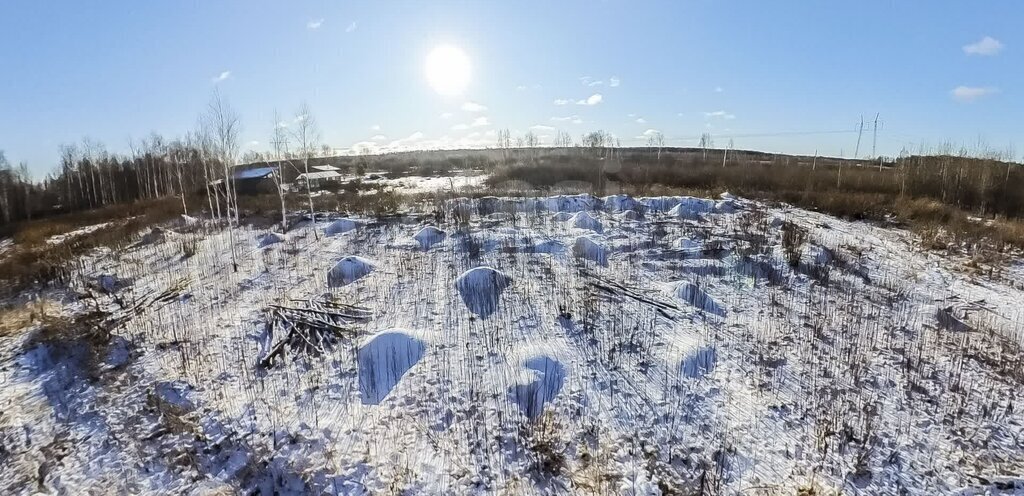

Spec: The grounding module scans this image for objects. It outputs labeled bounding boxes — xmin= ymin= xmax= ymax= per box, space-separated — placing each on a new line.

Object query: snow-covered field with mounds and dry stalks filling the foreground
xmin=0 ymin=196 xmax=1024 ymax=495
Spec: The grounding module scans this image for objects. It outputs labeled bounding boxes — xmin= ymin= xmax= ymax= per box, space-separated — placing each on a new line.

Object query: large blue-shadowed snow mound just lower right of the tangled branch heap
xmin=356 ymin=329 xmax=427 ymax=405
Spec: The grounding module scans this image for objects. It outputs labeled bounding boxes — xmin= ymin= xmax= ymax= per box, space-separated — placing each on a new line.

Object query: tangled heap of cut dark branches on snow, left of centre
xmin=258 ymin=295 xmax=372 ymax=369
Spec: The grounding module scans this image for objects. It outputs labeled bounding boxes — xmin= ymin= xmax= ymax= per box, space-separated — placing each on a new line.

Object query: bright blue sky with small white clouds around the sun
xmin=0 ymin=0 xmax=1024 ymax=175
